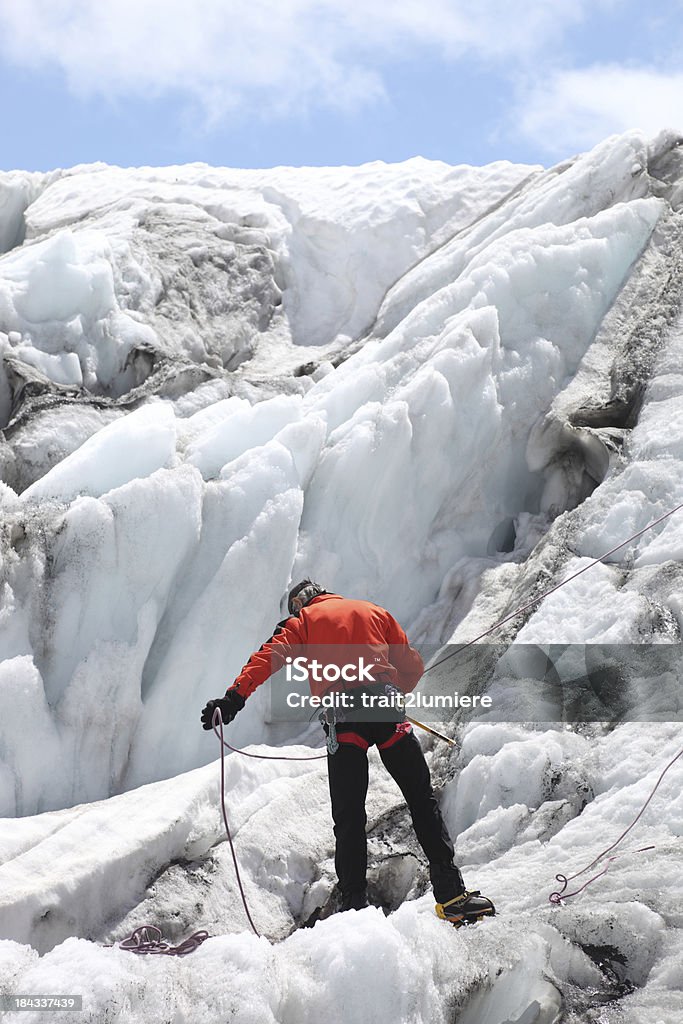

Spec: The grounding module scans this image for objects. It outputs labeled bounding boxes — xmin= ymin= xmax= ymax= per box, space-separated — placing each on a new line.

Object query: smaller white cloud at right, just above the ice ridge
xmin=515 ymin=65 xmax=683 ymax=156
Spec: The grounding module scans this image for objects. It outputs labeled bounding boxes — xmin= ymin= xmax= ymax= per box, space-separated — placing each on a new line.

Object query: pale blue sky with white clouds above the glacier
xmin=0 ymin=0 xmax=683 ymax=170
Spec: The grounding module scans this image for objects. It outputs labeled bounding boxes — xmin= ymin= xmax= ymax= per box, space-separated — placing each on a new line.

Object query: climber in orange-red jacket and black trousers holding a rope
xmin=202 ymin=580 xmax=496 ymax=927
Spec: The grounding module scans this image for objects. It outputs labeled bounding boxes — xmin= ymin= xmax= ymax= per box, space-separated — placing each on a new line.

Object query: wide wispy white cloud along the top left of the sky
xmin=0 ymin=0 xmax=589 ymax=119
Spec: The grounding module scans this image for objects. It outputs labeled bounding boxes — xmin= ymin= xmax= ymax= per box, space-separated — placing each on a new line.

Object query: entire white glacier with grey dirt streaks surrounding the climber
xmin=0 ymin=132 xmax=683 ymax=1024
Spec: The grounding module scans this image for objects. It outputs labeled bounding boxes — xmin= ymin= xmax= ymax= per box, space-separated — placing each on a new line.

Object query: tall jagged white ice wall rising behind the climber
xmin=0 ymin=133 xmax=671 ymax=814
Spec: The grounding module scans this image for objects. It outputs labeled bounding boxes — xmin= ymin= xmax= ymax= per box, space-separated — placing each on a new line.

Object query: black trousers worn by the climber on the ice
xmin=328 ymin=722 xmax=465 ymax=903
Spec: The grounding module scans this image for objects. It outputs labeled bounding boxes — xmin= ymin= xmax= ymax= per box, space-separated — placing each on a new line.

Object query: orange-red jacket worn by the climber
xmin=230 ymin=594 xmax=424 ymax=699
